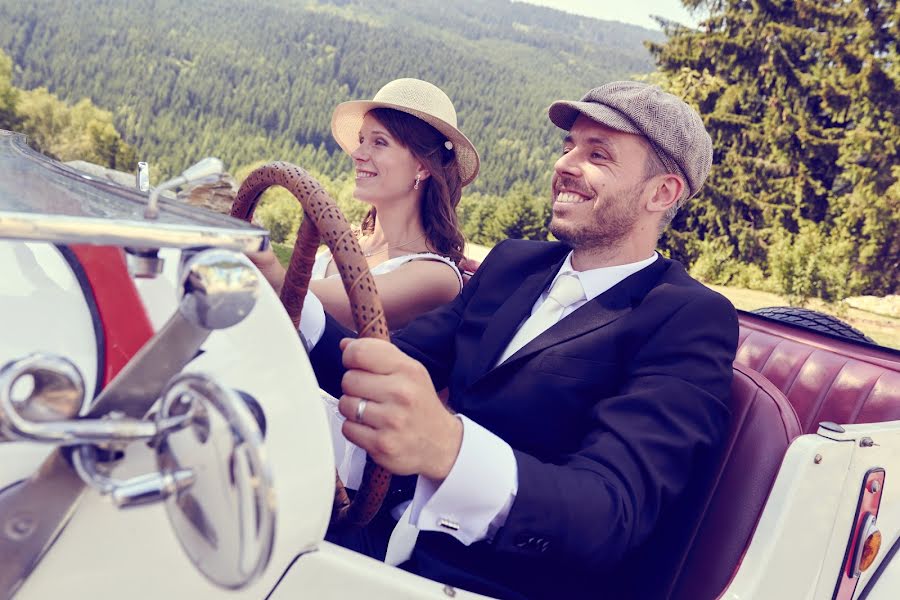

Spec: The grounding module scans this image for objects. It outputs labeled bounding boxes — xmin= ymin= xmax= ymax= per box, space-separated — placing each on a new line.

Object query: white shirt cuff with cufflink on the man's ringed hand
xmin=409 ymin=415 xmax=519 ymax=546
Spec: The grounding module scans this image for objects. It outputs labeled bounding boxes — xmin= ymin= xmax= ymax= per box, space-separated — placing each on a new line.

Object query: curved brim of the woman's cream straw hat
xmin=331 ymin=100 xmax=481 ymax=186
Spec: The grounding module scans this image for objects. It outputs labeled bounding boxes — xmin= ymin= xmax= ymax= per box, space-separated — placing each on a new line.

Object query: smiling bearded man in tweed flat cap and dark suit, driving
xmin=311 ymin=82 xmax=738 ymax=598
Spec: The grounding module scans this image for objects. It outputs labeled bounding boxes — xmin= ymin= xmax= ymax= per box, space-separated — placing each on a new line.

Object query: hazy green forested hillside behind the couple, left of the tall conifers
xmin=0 ymin=0 xmax=662 ymax=194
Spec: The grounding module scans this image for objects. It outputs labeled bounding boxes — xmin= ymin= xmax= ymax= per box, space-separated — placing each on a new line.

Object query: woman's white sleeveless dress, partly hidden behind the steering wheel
xmin=312 ymin=250 xmax=463 ymax=490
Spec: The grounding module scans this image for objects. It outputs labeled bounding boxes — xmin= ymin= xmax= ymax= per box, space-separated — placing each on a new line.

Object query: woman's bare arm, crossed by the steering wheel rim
xmin=309 ymin=260 xmax=459 ymax=331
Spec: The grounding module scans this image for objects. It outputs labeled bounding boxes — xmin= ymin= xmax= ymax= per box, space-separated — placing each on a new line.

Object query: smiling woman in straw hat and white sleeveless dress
xmin=253 ymin=79 xmax=479 ymax=329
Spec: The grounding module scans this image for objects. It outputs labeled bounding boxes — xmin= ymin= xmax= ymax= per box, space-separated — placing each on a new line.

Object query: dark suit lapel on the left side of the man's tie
xmin=469 ymin=252 xmax=568 ymax=383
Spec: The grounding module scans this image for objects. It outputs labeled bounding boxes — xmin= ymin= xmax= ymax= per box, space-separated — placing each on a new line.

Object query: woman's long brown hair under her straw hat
xmin=361 ymin=108 xmax=465 ymax=264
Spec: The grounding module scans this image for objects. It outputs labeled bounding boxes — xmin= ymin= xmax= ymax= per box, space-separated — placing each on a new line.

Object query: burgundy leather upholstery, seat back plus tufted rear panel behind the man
xmin=666 ymin=312 xmax=900 ymax=600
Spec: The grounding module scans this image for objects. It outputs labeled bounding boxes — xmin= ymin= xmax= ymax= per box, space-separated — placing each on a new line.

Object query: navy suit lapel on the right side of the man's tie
xmin=472 ymin=257 xmax=670 ymax=383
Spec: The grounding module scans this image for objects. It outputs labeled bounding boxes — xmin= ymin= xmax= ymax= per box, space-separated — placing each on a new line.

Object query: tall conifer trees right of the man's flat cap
xmin=651 ymin=0 xmax=900 ymax=303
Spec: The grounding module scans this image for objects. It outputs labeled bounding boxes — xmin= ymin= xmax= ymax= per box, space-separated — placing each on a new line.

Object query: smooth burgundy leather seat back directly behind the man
xmin=664 ymin=364 xmax=801 ymax=600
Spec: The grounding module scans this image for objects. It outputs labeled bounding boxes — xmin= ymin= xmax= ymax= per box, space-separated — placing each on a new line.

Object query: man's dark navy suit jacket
xmin=312 ymin=240 xmax=738 ymax=598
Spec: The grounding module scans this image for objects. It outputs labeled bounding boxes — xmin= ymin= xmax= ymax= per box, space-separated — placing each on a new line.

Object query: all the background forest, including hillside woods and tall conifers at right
xmin=0 ymin=0 xmax=900 ymax=305
